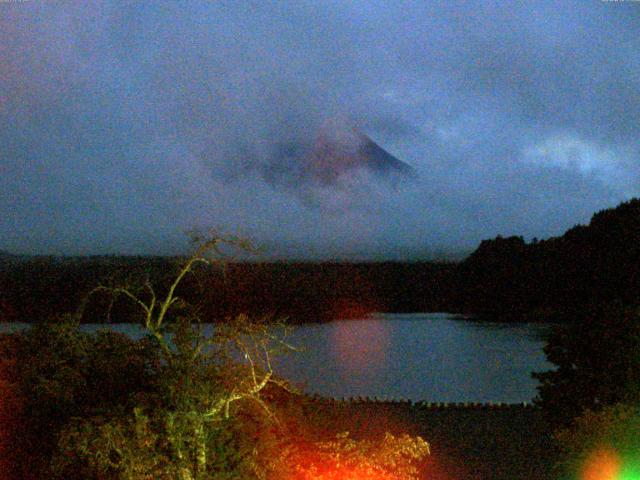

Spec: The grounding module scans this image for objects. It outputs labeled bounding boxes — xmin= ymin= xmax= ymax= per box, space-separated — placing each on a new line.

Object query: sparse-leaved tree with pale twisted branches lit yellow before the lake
xmin=73 ymin=234 xmax=293 ymax=480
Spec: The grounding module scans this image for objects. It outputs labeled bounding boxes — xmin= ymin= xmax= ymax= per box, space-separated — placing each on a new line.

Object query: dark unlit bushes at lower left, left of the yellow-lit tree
xmin=0 ymin=319 xmax=156 ymax=480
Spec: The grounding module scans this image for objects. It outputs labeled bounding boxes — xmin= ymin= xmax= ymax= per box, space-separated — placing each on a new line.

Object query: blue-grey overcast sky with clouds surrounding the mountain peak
xmin=0 ymin=0 xmax=640 ymax=258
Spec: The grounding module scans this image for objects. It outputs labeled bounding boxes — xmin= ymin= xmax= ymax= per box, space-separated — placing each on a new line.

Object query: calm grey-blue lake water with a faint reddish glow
xmin=0 ymin=313 xmax=552 ymax=403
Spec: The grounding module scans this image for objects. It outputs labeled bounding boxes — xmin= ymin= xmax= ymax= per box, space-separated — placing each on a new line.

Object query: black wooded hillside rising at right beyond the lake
xmin=452 ymin=199 xmax=640 ymax=317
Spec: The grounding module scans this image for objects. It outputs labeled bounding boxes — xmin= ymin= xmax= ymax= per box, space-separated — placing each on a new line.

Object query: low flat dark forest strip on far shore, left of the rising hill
xmin=0 ymin=256 xmax=453 ymax=323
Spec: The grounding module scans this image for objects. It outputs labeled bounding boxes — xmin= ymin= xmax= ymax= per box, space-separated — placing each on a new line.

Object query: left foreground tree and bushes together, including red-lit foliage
xmin=0 ymin=234 xmax=428 ymax=480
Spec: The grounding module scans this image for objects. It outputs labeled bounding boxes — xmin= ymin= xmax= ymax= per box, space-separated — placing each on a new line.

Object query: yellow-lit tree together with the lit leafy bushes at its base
xmin=57 ymin=238 xmax=298 ymax=480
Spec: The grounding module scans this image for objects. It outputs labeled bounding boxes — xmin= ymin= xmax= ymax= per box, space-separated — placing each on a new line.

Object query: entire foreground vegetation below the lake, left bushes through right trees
xmin=5 ymin=233 xmax=640 ymax=480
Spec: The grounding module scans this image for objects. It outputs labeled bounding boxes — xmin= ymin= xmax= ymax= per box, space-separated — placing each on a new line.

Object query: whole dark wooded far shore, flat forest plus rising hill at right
xmin=0 ymin=199 xmax=640 ymax=322
